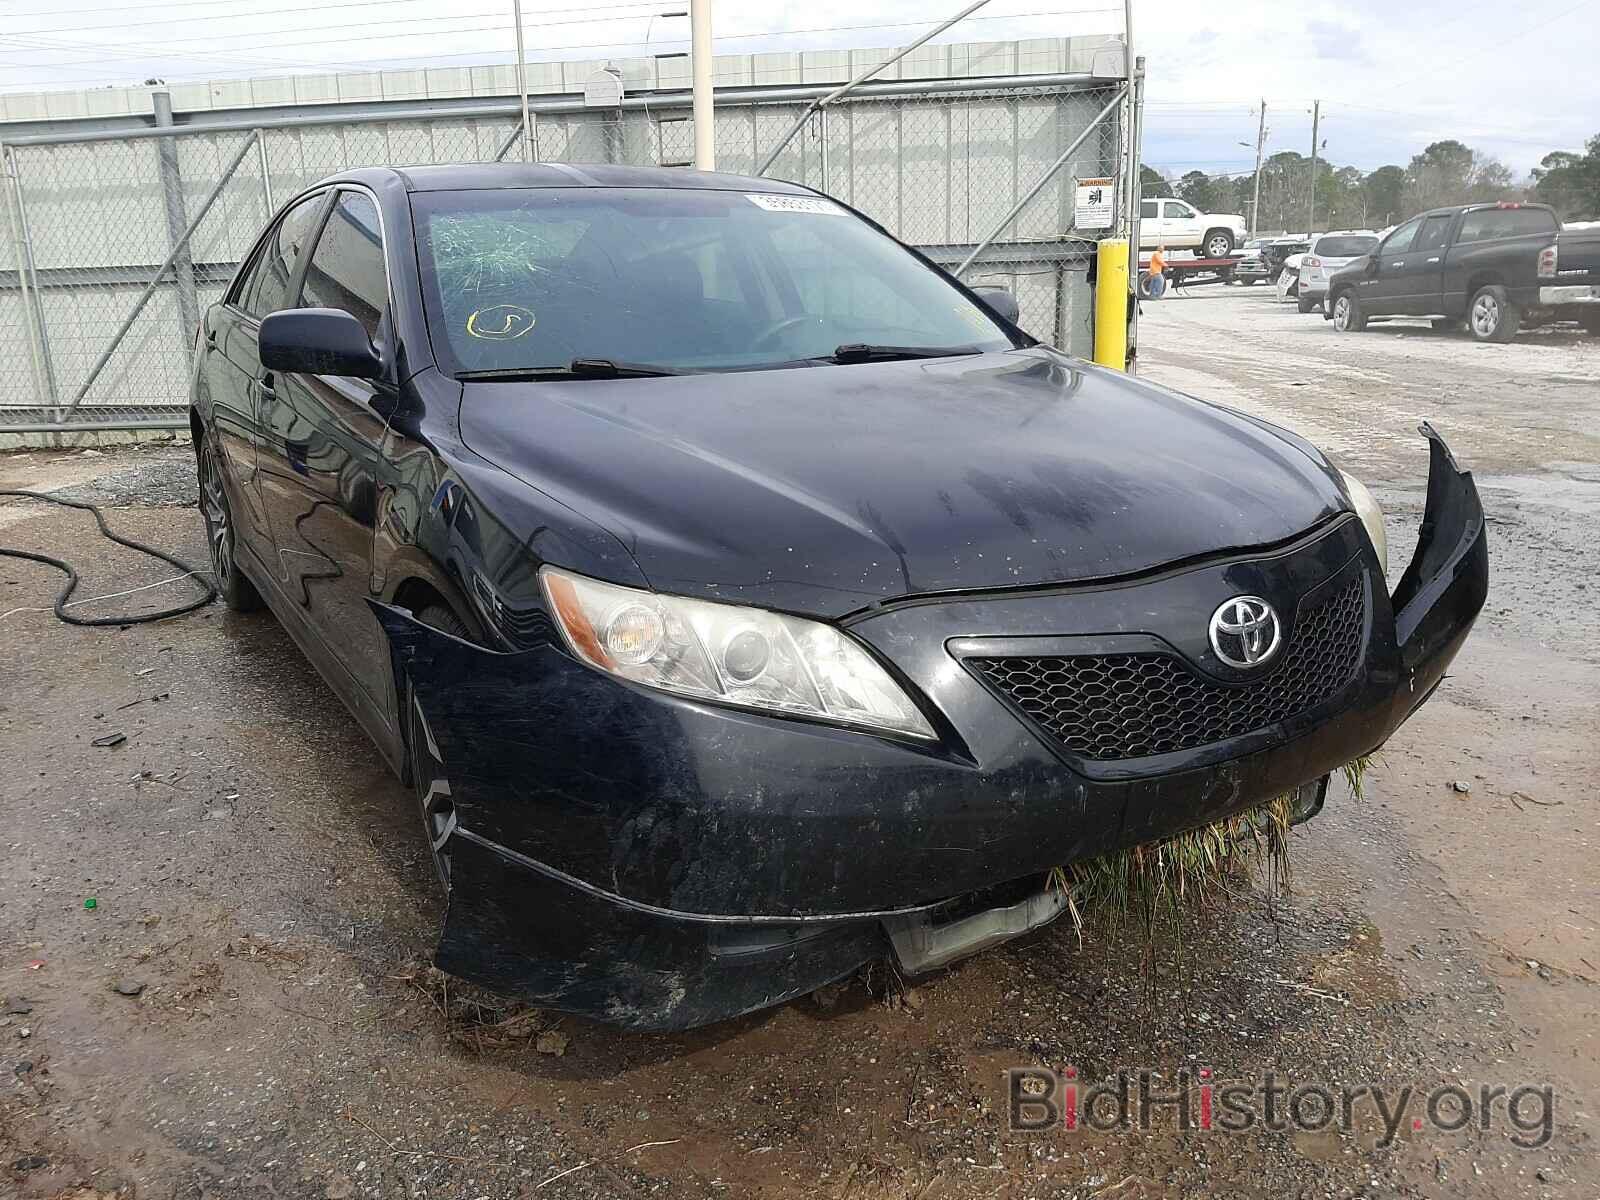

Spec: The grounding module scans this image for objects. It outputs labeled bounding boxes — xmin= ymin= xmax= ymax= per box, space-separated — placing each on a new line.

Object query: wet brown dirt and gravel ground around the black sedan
xmin=0 ymin=286 xmax=1600 ymax=1200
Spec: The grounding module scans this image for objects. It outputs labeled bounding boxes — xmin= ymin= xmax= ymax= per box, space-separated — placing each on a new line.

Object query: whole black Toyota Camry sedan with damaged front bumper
xmin=192 ymin=165 xmax=1488 ymax=1029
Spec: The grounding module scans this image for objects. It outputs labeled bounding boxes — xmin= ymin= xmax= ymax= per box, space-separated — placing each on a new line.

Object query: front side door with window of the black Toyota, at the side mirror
xmin=261 ymin=189 xmax=395 ymax=712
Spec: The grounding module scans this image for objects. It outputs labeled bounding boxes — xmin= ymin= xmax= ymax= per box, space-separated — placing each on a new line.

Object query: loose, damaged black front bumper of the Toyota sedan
xmin=379 ymin=426 xmax=1488 ymax=1029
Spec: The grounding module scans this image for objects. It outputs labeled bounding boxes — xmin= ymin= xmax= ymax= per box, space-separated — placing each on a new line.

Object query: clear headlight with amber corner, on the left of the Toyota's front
xmin=539 ymin=566 xmax=934 ymax=738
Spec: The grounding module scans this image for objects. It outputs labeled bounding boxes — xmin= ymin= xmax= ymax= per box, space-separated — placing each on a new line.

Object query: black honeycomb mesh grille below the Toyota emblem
xmin=968 ymin=573 xmax=1366 ymax=762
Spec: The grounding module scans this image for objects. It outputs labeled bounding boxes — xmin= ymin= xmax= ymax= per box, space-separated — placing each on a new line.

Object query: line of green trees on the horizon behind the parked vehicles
xmin=1142 ymin=134 xmax=1600 ymax=232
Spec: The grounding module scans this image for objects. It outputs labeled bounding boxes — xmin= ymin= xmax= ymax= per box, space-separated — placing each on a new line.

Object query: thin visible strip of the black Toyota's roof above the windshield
xmin=322 ymin=163 xmax=813 ymax=195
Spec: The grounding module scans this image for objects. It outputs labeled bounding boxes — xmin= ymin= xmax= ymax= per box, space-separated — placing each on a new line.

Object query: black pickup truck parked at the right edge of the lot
xmin=1323 ymin=203 xmax=1600 ymax=342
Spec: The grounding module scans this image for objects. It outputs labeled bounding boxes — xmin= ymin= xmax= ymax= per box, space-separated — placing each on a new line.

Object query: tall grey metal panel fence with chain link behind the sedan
xmin=0 ymin=77 xmax=1122 ymax=438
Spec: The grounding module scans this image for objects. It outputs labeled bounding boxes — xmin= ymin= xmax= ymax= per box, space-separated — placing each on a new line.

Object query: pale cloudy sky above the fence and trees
xmin=0 ymin=0 xmax=1600 ymax=176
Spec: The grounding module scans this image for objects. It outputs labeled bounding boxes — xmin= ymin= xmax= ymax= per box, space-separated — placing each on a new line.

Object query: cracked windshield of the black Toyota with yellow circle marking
xmin=411 ymin=187 xmax=1013 ymax=373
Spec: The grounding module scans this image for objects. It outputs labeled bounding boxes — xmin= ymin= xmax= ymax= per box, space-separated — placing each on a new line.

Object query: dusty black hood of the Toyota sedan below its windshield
xmin=461 ymin=347 xmax=1347 ymax=616
